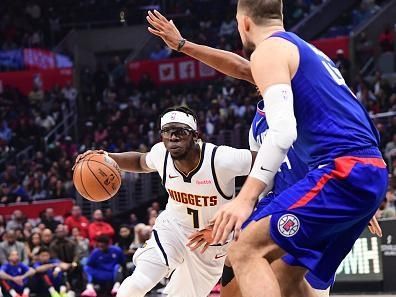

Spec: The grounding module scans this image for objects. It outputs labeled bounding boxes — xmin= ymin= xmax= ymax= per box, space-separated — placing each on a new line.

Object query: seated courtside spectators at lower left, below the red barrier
xmin=0 ymin=202 xmax=160 ymax=297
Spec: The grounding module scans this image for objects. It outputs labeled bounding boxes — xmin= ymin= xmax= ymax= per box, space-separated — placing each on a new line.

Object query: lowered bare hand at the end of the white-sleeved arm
xmin=213 ymin=197 xmax=254 ymax=244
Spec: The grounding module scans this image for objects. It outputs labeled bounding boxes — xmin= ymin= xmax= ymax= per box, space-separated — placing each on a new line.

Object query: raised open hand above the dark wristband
xmin=146 ymin=10 xmax=183 ymax=50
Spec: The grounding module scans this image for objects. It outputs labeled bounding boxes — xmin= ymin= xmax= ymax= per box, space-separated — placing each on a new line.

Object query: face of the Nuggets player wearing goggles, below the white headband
xmin=161 ymin=123 xmax=196 ymax=160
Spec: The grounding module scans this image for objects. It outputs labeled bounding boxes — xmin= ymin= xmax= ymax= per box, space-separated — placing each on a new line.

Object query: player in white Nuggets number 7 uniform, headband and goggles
xmin=76 ymin=107 xmax=253 ymax=297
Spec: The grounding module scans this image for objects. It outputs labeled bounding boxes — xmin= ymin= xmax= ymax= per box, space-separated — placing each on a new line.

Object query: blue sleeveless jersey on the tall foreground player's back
xmin=270 ymin=32 xmax=380 ymax=168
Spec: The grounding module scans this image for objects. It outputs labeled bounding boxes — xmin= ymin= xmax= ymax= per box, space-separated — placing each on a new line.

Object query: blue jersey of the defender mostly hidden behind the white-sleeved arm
xmin=251 ymin=100 xmax=308 ymax=195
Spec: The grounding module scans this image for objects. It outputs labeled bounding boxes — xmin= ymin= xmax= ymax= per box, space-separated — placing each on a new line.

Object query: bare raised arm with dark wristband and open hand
xmin=146 ymin=10 xmax=254 ymax=84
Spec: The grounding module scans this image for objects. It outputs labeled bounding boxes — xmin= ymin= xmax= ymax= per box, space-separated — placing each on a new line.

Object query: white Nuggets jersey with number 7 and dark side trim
xmin=146 ymin=142 xmax=252 ymax=229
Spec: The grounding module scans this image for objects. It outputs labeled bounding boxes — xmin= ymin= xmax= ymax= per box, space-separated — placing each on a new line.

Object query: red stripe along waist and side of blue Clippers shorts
xmin=289 ymin=156 xmax=386 ymax=209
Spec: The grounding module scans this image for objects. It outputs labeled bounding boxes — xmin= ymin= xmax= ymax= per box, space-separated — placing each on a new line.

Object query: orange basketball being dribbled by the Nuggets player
xmin=73 ymin=154 xmax=121 ymax=202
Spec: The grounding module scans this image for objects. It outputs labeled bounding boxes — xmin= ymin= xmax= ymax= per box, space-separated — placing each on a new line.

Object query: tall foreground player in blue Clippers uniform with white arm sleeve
xmin=204 ymin=0 xmax=387 ymax=297
